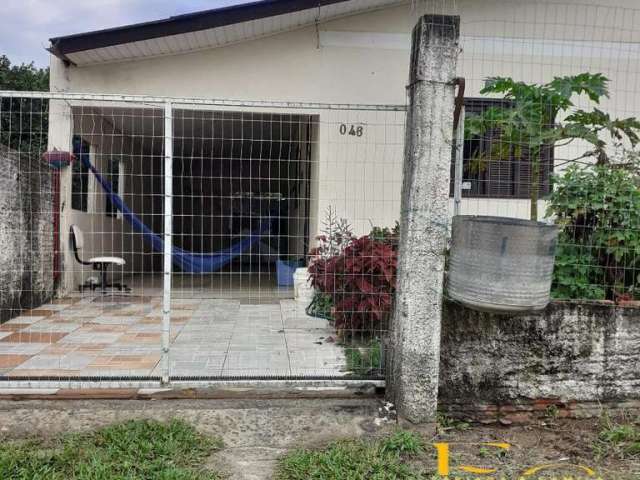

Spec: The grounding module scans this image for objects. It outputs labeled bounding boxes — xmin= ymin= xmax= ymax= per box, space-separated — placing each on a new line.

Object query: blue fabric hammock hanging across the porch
xmin=80 ymin=155 xmax=271 ymax=273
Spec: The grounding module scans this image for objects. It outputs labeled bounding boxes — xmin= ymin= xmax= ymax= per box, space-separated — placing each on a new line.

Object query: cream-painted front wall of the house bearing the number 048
xmin=51 ymin=0 xmax=640 ymax=258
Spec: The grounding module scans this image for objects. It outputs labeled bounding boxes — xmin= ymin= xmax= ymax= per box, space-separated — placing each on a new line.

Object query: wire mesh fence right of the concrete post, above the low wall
xmin=440 ymin=1 xmax=640 ymax=304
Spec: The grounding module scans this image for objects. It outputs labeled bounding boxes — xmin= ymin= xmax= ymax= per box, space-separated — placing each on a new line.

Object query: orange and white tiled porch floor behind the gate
xmin=0 ymin=292 xmax=345 ymax=377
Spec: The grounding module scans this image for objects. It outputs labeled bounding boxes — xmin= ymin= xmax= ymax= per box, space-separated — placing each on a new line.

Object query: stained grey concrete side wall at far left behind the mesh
xmin=0 ymin=146 xmax=54 ymax=322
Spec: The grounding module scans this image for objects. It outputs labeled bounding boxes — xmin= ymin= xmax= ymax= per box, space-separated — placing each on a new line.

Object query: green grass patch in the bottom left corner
xmin=0 ymin=420 xmax=222 ymax=480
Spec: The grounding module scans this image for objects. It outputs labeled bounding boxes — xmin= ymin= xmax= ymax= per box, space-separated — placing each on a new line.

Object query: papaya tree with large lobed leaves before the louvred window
xmin=465 ymin=73 xmax=640 ymax=220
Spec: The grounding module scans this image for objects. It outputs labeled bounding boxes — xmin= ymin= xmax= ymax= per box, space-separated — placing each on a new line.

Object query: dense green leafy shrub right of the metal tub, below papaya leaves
xmin=547 ymin=165 xmax=640 ymax=300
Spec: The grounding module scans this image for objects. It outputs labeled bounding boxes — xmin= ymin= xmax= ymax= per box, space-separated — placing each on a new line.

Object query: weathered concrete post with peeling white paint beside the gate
xmin=387 ymin=15 xmax=460 ymax=423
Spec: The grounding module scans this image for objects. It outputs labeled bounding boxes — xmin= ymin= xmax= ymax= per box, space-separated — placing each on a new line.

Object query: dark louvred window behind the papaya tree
xmin=450 ymin=98 xmax=553 ymax=199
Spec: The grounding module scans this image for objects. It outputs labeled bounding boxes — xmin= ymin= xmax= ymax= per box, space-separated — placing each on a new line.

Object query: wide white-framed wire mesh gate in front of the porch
xmin=0 ymin=92 xmax=405 ymax=385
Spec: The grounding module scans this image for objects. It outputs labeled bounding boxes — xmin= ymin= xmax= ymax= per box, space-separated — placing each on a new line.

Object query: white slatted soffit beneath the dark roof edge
xmin=66 ymin=0 xmax=407 ymax=66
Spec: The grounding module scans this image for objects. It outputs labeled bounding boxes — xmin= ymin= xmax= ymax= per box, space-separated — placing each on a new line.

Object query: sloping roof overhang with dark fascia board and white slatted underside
xmin=49 ymin=0 xmax=408 ymax=66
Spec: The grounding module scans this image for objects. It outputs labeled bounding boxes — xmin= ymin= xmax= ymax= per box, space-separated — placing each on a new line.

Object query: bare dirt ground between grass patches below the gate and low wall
xmin=0 ymin=398 xmax=640 ymax=480
